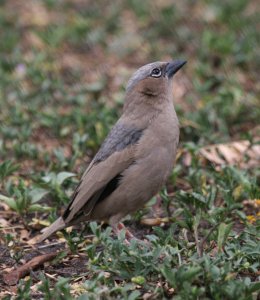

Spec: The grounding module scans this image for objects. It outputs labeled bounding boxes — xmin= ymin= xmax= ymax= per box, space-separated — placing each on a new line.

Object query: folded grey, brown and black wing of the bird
xmin=62 ymin=120 xmax=143 ymax=224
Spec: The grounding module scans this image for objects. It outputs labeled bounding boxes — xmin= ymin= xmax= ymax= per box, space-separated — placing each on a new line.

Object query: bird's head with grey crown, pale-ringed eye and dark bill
xmin=126 ymin=60 xmax=186 ymax=98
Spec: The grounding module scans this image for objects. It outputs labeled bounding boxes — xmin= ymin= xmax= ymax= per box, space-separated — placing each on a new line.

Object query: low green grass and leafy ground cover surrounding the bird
xmin=0 ymin=0 xmax=260 ymax=300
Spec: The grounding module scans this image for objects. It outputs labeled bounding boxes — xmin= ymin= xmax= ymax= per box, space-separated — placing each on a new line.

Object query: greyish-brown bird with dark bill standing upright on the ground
xmin=37 ymin=60 xmax=186 ymax=243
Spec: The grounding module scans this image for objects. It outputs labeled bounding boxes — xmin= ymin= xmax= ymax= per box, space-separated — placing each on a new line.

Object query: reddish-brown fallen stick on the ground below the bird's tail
xmin=3 ymin=252 xmax=59 ymax=285
